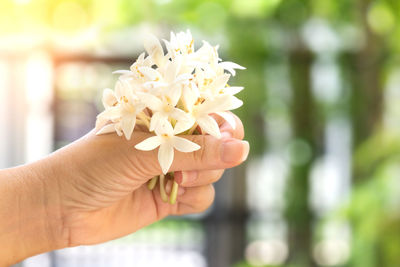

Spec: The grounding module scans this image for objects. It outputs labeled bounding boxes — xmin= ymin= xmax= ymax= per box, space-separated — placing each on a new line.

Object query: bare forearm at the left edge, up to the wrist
xmin=0 ymin=162 xmax=64 ymax=266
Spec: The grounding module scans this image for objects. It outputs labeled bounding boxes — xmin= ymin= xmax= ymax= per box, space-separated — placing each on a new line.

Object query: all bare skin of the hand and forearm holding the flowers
xmin=0 ymin=114 xmax=249 ymax=266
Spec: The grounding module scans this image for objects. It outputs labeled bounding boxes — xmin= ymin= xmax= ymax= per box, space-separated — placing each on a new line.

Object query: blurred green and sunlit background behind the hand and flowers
xmin=0 ymin=0 xmax=400 ymax=267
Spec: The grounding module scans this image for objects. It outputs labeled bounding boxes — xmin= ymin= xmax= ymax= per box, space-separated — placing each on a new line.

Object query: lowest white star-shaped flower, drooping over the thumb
xmin=135 ymin=123 xmax=200 ymax=174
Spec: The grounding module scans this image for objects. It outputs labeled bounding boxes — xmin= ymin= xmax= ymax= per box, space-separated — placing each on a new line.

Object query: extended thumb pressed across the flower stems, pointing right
xmin=130 ymin=134 xmax=249 ymax=178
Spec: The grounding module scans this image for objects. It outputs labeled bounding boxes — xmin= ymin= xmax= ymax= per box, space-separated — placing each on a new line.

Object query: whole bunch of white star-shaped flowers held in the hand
xmin=96 ymin=30 xmax=244 ymax=174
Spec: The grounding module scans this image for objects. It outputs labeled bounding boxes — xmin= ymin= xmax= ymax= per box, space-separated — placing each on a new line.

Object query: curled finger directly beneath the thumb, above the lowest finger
xmin=175 ymin=170 xmax=224 ymax=187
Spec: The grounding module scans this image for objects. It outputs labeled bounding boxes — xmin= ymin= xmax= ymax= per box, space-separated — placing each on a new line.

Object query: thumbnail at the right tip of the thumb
xmin=221 ymin=139 xmax=249 ymax=163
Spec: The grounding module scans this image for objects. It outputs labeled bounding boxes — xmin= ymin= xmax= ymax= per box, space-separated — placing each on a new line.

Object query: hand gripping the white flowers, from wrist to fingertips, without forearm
xmin=0 ymin=113 xmax=249 ymax=266
